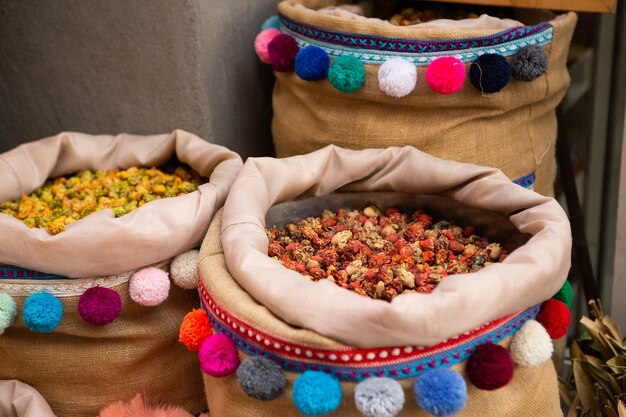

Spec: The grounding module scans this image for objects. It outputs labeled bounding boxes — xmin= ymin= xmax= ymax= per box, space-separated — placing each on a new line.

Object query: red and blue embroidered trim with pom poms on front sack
xmin=199 ymin=277 xmax=560 ymax=417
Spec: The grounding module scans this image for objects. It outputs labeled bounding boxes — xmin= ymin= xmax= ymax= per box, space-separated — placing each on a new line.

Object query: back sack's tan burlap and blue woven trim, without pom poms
xmin=272 ymin=0 xmax=576 ymax=195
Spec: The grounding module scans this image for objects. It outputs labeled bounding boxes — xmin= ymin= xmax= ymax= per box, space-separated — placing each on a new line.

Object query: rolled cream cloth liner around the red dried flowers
xmin=222 ymin=145 xmax=571 ymax=347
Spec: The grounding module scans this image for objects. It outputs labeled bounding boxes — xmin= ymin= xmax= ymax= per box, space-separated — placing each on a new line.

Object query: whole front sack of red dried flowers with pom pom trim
xmin=195 ymin=146 xmax=571 ymax=417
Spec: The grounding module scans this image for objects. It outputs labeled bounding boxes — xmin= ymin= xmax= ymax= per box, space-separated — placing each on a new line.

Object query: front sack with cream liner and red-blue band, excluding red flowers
xmin=198 ymin=146 xmax=571 ymax=417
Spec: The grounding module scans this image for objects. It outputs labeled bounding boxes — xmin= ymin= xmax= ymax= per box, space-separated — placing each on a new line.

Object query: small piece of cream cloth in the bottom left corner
xmin=0 ymin=379 xmax=56 ymax=417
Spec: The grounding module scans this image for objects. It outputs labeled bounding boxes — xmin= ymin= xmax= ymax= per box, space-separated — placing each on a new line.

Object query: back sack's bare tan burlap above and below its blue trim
xmin=272 ymin=0 xmax=576 ymax=195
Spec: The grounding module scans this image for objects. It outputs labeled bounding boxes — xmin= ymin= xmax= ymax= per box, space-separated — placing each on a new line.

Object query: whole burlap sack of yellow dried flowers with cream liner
xmin=0 ymin=130 xmax=242 ymax=417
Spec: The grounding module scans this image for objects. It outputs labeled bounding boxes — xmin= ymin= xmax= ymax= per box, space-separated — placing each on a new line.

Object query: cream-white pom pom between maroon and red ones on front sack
xmin=509 ymin=320 xmax=554 ymax=368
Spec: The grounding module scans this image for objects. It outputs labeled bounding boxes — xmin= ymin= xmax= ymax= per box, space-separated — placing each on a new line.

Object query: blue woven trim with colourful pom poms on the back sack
xmin=255 ymin=15 xmax=554 ymax=97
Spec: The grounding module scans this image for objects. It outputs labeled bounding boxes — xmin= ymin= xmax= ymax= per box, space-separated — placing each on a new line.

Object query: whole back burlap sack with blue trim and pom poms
xmin=255 ymin=0 xmax=576 ymax=195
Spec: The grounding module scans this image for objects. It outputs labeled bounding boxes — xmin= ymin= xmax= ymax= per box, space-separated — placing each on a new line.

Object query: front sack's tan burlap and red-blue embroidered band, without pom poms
xmin=198 ymin=211 xmax=561 ymax=417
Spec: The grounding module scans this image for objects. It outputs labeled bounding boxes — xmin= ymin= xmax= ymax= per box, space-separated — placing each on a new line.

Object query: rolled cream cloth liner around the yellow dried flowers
xmin=0 ymin=130 xmax=242 ymax=278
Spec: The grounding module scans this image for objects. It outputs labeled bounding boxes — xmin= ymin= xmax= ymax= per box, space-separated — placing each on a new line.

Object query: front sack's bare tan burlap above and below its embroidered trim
xmin=198 ymin=210 xmax=561 ymax=417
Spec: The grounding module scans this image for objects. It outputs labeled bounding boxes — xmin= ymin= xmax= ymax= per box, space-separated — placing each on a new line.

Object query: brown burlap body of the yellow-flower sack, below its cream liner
xmin=0 ymin=261 xmax=205 ymax=417
